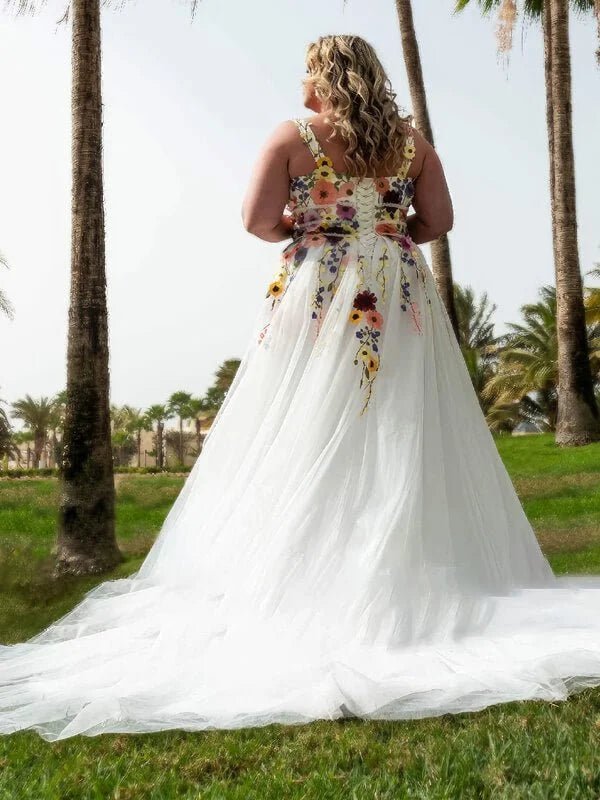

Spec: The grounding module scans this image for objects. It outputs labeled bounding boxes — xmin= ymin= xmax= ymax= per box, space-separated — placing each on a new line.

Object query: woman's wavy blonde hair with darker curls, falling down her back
xmin=306 ymin=35 xmax=410 ymax=176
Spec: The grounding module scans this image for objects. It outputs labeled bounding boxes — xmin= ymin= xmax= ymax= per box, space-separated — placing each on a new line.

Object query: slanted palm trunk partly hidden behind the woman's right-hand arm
xmin=396 ymin=0 xmax=459 ymax=340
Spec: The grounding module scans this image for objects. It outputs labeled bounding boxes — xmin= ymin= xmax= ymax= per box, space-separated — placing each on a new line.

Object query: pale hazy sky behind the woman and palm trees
xmin=0 ymin=0 xmax=600 ymax=408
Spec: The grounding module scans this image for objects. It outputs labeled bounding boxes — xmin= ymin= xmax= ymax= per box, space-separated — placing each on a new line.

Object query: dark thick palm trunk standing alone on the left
xmin=56 ymin=0 xmax=122 ymax=575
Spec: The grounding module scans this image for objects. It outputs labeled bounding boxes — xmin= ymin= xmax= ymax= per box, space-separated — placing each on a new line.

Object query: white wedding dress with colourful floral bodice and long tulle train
xmin=0 ymin=120 xmax=600 ymax=740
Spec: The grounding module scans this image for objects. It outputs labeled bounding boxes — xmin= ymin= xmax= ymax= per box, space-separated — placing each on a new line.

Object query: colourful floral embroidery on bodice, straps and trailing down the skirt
xmin=259 ymin=120 xmax=424 ymax=414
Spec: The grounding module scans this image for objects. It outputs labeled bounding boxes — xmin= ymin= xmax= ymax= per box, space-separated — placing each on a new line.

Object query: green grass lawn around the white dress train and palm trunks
xmin=0 ymin=436 xmax=600 ymax=800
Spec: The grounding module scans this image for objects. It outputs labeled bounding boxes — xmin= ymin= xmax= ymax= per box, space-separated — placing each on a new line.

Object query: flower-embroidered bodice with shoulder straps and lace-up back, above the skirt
xmin=288 ymin=119 xmax=415 ymax=249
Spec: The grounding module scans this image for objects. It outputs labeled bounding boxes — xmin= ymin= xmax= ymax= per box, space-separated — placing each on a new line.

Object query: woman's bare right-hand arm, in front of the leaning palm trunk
xmin=406 ymin=134 xmax=454 ymax=244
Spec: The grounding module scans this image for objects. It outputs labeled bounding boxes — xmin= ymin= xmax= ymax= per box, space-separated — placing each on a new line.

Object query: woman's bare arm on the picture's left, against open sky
xmin=242 ymin=121 xmax=295 ymax=242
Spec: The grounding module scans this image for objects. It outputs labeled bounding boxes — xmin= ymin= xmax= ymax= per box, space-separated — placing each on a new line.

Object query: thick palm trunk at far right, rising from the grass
xmin=544 ymin=0 xmax=600 ymax=445
